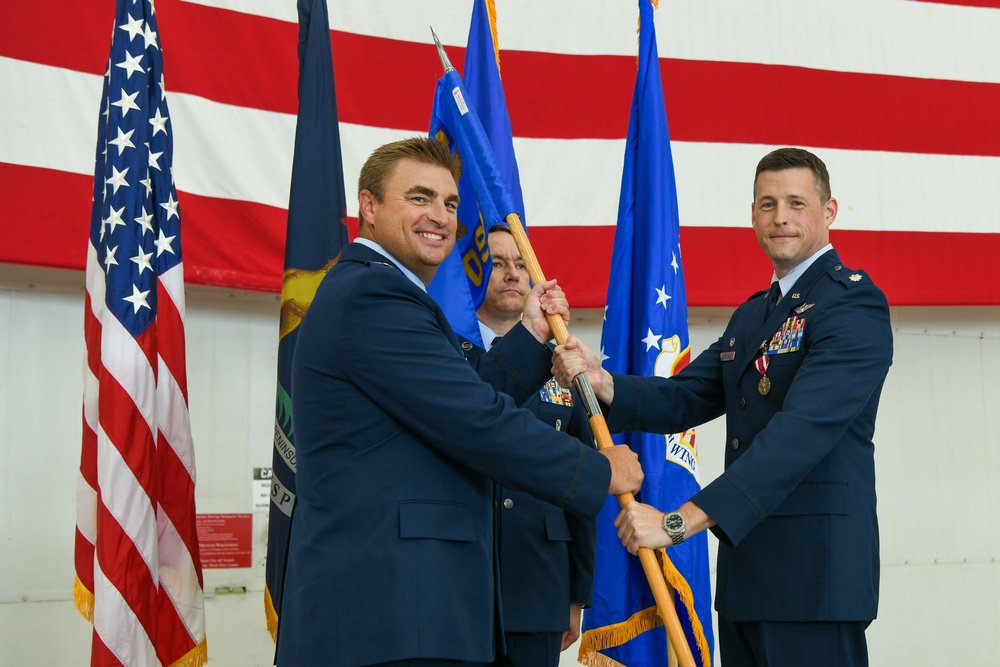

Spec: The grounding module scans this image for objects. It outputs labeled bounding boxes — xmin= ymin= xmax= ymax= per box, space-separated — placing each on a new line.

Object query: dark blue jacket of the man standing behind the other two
xmin=460 ymin=336 xmax=597 ymax=633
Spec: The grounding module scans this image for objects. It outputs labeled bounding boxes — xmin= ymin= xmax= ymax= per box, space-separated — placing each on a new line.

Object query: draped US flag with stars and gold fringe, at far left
xmin=73 ymin=0 xmax=208 ymax=667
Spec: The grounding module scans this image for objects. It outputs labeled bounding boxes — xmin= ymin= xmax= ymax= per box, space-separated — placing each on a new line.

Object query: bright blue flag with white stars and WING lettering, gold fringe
xmin=580 ymin=0 xmax=713 ymax=667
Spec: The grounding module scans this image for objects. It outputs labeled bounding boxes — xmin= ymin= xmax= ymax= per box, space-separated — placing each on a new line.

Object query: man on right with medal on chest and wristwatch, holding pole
xmin=553 ymin=148 xmax=892 ymax=667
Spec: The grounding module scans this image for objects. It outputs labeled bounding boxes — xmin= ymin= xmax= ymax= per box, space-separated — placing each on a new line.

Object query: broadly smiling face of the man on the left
xmin=358 ymin=158 xmax=458 ymax=285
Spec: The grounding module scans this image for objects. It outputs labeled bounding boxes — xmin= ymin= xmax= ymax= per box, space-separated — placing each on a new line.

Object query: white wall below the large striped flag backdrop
xmin=0 ymin=265 xmax=1000 ymax=667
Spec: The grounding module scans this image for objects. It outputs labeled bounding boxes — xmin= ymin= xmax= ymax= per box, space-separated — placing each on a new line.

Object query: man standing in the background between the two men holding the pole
xmin=462 ymin=225 xmax=597 ymax=667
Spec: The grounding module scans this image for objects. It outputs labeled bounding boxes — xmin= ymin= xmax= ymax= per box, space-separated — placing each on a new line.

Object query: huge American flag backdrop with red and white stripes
xmin=0 ymin=0 xmax=1000 ymax=307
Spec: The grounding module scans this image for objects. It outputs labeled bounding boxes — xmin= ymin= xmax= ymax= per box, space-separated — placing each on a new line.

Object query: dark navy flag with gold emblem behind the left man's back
xmin=264 ymin=0 xmax=347 ymax=638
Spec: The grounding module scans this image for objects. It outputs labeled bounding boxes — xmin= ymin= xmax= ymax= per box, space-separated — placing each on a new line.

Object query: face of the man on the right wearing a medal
xmin=751 ymin=167 xmax=837 ymax=278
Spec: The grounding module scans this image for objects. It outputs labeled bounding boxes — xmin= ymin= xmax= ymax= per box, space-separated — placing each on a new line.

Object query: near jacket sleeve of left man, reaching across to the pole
xmin=328 ymin=274 xmax=611 ymax=516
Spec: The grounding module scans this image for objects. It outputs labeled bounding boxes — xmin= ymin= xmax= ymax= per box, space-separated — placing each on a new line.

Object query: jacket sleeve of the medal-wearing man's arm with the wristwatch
xmin=692 ymin=284 xmax=892 ymax=546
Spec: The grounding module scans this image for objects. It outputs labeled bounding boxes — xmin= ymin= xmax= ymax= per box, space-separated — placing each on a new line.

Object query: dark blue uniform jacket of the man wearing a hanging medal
xmin=608 ymin=250 xmax=892 ymax=621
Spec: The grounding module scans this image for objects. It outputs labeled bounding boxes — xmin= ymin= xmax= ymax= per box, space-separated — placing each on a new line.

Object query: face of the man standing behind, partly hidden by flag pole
xmin=476 ymin=232 xmax=531 ymax=335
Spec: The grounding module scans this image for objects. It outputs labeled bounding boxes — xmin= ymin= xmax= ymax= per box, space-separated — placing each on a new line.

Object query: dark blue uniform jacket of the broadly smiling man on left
xmin=278 ymin=244 xmax=611 ymax=667
